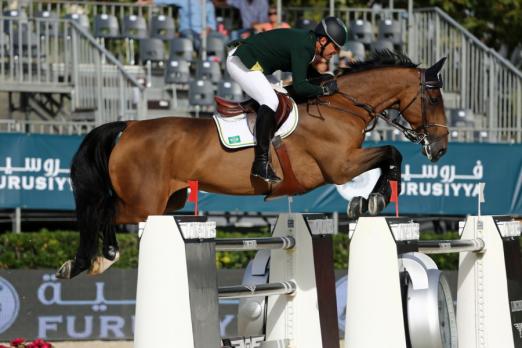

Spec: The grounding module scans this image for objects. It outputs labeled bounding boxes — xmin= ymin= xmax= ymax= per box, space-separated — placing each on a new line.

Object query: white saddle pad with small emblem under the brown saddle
xmin=214 ymin=100 xmax=299 ymax=149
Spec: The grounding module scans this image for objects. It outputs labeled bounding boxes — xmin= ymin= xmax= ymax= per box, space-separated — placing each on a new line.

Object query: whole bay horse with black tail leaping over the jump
xmin=56 ymin=52 xmax=448 ymax=279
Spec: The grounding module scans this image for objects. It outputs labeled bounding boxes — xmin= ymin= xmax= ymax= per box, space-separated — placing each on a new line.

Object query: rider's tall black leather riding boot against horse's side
xmin=251 ymin=105 xmax=281 ymax=183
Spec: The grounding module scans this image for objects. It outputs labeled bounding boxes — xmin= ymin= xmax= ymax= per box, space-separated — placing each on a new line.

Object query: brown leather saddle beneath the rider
xmin=214 ymin=91 xmax=292 ymax=128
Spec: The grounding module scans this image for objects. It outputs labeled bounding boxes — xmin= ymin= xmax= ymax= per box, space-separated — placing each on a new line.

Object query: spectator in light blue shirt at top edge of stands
xmin=138 ymin=0 xmax=216 ymax=51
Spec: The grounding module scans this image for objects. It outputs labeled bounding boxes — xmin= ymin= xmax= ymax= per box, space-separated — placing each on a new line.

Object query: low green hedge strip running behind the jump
xmin=0 ymin=230 xmax=516 ymax=270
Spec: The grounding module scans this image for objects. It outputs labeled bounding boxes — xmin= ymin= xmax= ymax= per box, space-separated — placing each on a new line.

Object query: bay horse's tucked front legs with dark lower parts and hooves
xmin=347 ymin=145 xmax=402 ymax=219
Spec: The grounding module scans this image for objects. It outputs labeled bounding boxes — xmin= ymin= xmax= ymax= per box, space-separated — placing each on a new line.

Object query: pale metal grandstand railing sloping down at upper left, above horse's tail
xmin=0 ymin=17 xmax=146 ymax=125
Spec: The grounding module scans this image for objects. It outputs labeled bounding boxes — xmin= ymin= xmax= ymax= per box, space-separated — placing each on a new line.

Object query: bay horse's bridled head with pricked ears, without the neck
xmin=400 ymin=58 xmax=449 ymax=162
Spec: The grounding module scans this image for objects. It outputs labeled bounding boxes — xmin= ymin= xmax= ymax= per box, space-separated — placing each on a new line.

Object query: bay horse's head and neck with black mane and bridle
xmin=333 ymin=50 xmax=449 ymax=162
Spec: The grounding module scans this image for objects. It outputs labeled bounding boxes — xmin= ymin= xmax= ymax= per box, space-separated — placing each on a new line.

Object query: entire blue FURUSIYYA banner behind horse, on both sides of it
xmin=0 ymin=134 xmax=522 ymax=215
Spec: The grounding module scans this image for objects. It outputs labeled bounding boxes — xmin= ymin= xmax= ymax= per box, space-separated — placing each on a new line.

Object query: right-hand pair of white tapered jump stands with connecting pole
xmin=345 ymin=216 xmax=522 ymax=348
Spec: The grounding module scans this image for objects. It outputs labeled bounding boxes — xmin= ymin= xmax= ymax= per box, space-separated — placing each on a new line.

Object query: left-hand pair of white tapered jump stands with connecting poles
xmin=134 ymin=214 xmax=339 ymax=348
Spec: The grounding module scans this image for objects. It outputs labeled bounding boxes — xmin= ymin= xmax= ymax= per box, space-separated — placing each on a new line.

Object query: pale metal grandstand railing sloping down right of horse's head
xmin=410 ymin=8 xmax=522 ymax=142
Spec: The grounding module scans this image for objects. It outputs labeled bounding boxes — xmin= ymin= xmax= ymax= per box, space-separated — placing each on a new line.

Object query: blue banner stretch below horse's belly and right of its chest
xmin=184 ymin=142 xmax=522 ymax=215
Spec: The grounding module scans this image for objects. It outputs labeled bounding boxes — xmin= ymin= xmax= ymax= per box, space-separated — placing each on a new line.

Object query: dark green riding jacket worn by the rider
xmin=234 ymin=29 xmax=323 ymax=98
